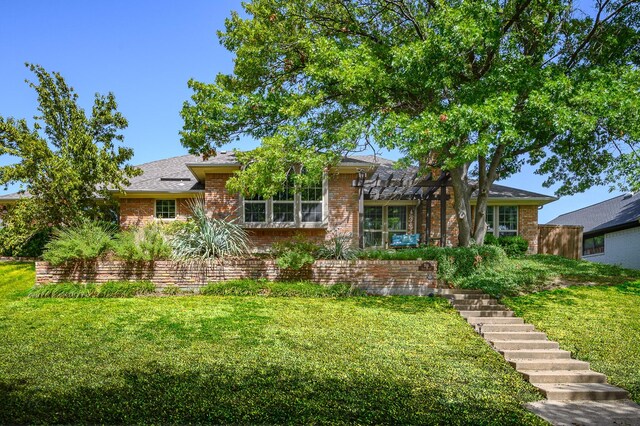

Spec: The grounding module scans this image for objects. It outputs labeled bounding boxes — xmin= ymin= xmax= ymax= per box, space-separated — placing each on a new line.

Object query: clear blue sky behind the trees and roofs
xmin=0 ymin=0 xmax=619 ymax=223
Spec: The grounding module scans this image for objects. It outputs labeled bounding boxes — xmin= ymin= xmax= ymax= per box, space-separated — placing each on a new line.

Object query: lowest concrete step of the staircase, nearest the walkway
xmin=534 ymin=383 xmax=629 ymax=401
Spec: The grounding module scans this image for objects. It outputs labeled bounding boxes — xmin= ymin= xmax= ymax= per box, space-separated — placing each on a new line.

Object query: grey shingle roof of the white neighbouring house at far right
xmin=549 ymin=193 xmax=640 ymax=234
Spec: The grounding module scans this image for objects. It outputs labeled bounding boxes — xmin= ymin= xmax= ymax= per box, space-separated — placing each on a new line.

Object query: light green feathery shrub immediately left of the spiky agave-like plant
xmin=113 ymin=222 xmax=172 ymax=262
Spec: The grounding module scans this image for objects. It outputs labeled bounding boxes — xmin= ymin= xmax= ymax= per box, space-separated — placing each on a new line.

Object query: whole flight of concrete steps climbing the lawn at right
xmin=434 ymin=289 xmax=629 ymax=401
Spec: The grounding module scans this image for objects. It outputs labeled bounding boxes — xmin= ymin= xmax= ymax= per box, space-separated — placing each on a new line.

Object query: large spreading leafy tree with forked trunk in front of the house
xmin=182 ymin=0 xmax=640 ymax=245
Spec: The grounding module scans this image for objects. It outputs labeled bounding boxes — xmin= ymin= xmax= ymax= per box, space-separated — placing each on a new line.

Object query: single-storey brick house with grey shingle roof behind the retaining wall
xmin=0 ymin=152 xmax=555 ymax=253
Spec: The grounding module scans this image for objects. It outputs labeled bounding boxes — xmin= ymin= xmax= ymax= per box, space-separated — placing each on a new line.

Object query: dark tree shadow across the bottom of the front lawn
xmin=0 ymin=364 xmax=537 ymax=424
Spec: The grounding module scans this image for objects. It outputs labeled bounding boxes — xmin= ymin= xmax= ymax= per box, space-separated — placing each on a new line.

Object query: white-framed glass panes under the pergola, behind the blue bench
xmin=363 ymin=206 xmax=407 ymax=247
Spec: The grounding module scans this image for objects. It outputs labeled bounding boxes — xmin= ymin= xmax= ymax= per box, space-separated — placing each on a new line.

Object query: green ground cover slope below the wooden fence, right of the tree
xmin=453 ymin=255 xmax=640 ymax=297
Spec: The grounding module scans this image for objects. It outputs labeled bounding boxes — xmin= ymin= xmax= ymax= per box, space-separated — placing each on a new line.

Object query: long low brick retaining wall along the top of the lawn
xmin=36 ymin=259 xmax=438 ymax=294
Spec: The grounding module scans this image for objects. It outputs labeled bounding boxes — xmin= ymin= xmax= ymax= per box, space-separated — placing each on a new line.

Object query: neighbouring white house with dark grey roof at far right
xmin=549 ymin=193 xmax=640 ymax=269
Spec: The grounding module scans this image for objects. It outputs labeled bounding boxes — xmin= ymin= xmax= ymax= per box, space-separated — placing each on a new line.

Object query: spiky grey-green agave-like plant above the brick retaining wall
xmin=171 ymin=198 xmax=249 ymax=261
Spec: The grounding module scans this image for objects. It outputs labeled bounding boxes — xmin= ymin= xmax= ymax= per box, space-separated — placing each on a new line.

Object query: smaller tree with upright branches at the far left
xmin=0 ymin=64 xmax=138 ymax=250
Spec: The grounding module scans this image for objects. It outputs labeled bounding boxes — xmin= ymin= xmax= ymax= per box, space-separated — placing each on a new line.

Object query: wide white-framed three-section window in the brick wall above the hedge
xmin=244 ymin=180 xmax=324 ymax=225
